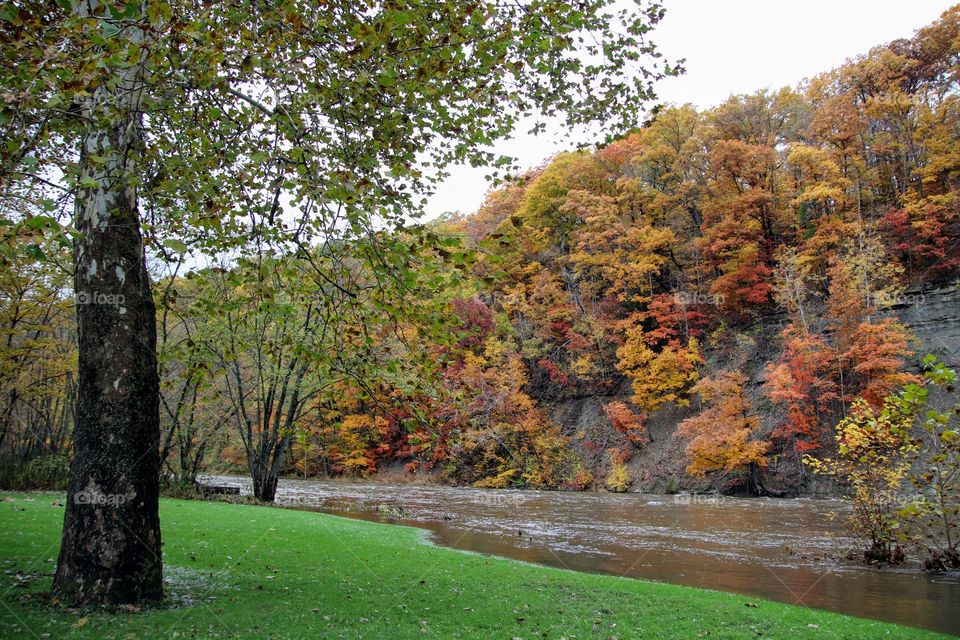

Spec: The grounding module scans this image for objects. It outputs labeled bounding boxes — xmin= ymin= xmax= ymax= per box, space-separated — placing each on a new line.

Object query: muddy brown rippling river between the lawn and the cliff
xmin=205 ymin=476 xmax=960 ymax=634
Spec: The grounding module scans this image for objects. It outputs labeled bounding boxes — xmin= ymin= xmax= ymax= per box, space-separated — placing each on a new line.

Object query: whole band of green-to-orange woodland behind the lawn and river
xmin=0 ymin=8 xmax=960 ymax=524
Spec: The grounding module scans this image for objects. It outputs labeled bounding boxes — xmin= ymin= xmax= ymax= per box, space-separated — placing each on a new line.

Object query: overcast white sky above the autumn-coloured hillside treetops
xmin=427 ymin=0 xmax=954 ymax=217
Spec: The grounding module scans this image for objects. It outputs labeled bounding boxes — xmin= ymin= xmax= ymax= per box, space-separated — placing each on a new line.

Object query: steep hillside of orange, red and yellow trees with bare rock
xmin=414 ymin=8 xmax=960 ymax=495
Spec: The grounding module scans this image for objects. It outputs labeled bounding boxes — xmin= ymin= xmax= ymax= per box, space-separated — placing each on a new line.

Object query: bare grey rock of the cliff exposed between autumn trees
xmin=551 ymin=282 xmax=960 ymax=495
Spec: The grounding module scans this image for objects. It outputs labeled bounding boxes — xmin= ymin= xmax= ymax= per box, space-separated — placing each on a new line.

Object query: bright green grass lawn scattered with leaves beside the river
xmin=0 ymin=493 xmax=944 ymax=640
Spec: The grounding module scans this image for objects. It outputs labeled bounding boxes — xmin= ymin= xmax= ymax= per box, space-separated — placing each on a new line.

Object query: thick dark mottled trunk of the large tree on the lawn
xmin=53 ymin=2 xmax=163 ymax=604
